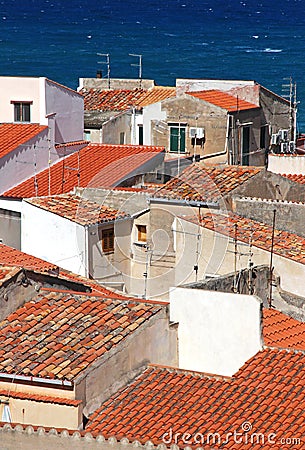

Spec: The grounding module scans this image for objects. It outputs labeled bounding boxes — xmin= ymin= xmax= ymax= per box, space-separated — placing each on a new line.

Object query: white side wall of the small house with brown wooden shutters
xmin=21 ymin=201 xmax=87 ymax=276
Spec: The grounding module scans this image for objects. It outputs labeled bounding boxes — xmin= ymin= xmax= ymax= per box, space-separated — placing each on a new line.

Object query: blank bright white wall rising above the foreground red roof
xmin=170 ymin=288 xmax=262 ymax=376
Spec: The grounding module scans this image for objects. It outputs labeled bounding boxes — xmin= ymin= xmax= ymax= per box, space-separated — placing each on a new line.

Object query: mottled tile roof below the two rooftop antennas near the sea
xmin=79 ymin=87 xmax=176 ymax=111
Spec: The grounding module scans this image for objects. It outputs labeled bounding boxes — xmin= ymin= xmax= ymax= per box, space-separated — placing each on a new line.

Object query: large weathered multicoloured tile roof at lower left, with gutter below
xmin=0 ymin=292 xmax=162 ymax=381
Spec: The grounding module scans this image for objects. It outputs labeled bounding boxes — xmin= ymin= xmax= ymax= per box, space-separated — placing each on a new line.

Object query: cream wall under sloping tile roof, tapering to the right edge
xmin=175 ymin=218 xmax=305 ymax=297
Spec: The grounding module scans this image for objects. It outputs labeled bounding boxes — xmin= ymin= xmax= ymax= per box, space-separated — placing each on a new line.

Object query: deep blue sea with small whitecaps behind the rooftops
xmin=0 ymin=0 xmax=305 ymax=131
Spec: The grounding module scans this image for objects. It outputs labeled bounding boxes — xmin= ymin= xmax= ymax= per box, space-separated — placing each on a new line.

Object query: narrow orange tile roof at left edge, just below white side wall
xmin=0 ymin=244 xmax=58 ymax=273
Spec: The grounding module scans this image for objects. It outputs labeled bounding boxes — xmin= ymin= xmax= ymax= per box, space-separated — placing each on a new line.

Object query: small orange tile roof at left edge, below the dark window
xmin=0 ymin=123 xmax=48 ymax=158
